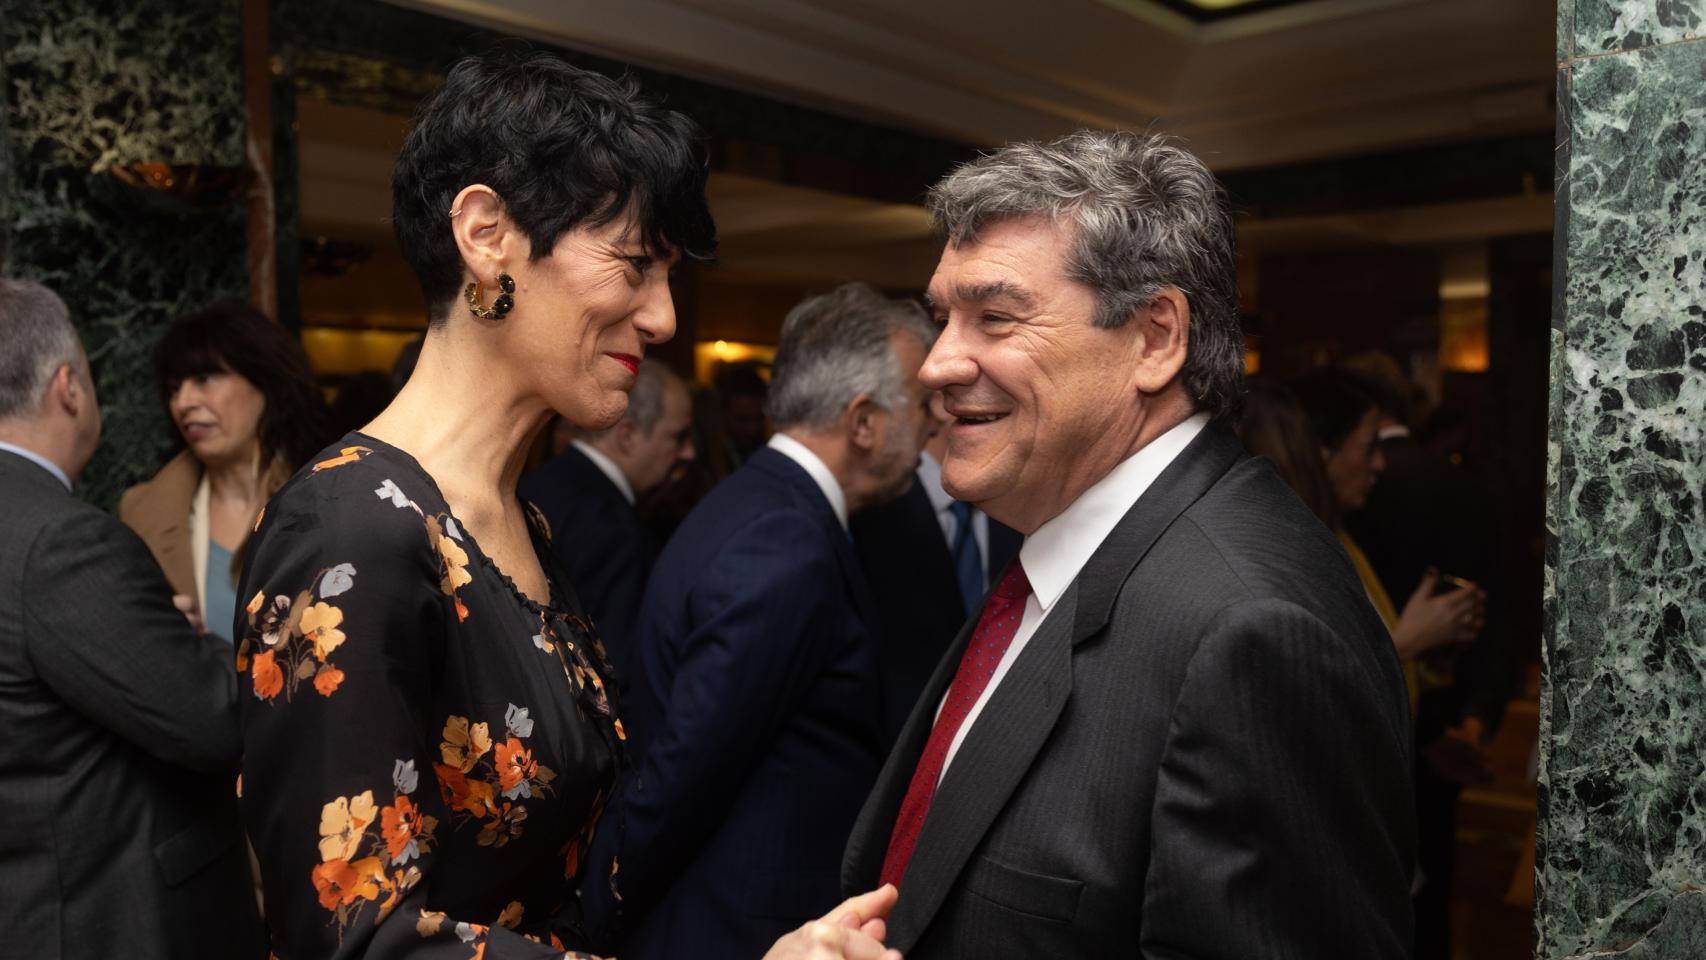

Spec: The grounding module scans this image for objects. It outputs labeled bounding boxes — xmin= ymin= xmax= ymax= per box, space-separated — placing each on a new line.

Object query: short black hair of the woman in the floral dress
xmin=391 ymin=55 xmax=717 ymax=324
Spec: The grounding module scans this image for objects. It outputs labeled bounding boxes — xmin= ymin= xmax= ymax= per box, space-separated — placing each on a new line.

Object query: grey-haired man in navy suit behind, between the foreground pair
xmin=583 ymin=285 xmax=935 ymax=960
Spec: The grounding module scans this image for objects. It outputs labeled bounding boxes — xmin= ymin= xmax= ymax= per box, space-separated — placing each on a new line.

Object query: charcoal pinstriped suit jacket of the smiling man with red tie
xmin=843 ymin=423 xmax=1414 ymax=960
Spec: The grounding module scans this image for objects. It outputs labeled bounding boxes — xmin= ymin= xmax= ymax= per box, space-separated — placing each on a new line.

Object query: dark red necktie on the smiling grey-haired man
xmin=882 ymin=559 xmax=1030 ymax=887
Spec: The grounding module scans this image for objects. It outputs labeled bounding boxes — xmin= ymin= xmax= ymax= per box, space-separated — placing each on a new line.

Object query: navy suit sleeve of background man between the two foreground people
xmin=594 ymin=513 xmax=841 ymax=928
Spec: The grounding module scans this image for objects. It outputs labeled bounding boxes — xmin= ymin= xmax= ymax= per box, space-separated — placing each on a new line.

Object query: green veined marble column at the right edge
xmin=1537 ymin=0 xmax=1706 ymax=960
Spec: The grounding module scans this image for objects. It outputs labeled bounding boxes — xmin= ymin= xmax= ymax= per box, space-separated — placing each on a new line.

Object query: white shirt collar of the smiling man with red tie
xmin=1018 ymin=413 xmax=1208 ymax=612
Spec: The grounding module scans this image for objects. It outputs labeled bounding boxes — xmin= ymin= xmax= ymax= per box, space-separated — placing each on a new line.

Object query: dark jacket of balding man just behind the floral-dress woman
xmin=517 ymin=447 xmax=655 ymax=689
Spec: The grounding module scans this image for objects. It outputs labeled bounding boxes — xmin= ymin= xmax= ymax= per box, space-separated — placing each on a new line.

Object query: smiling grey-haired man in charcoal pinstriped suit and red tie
xmin=843 ymin=131 xmax=1414 ymax=960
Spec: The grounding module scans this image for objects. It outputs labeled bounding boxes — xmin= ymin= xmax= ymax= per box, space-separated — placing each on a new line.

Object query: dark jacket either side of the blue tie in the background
xmin=853 ymin=481 xmax=1024 ymax=745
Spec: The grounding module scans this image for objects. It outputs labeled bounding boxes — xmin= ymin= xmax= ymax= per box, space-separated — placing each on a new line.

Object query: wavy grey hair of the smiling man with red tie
xmin=928 ymin=130 xmax=1244 ymax=416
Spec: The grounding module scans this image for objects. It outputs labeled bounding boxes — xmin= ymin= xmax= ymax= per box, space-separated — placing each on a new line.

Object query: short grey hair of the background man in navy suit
xmin=764 ymin=283 xmax=937 ymax=430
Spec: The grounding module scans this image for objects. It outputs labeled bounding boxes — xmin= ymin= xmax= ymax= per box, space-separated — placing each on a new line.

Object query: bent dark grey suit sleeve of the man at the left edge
xmin=24 ymin=510 xmax=239 ymax=772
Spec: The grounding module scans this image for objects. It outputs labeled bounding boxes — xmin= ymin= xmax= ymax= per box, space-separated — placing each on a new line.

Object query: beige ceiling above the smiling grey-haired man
xmin=392 ymin=0 xmax=1554 ymax=171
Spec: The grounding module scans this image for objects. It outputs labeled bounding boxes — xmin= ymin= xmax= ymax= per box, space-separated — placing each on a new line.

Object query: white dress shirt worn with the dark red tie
xmin=937 ymin=413 xmax=1208 ymax=783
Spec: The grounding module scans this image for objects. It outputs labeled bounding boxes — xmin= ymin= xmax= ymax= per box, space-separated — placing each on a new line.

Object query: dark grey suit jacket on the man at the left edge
xmin=0 ymin=452 xmax=266 ymax=960
